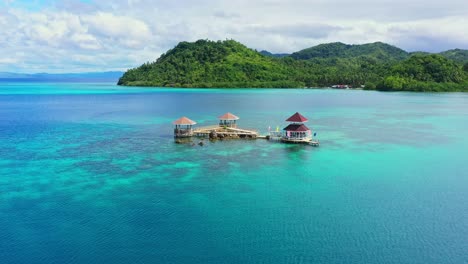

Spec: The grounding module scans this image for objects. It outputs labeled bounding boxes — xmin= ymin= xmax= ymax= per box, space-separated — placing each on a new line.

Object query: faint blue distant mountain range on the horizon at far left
xmin=0 ymin=71 xmax=123 ymax=82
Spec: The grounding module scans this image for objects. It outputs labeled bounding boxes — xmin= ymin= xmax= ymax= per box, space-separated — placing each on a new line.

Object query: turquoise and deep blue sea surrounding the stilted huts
xmin=0 ymin=83 xmax=468 ymax=263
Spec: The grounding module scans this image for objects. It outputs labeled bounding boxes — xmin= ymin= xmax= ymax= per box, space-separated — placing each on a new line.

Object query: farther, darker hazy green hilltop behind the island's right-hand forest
xmin=291 ymin=42 xmax=409 ymax=61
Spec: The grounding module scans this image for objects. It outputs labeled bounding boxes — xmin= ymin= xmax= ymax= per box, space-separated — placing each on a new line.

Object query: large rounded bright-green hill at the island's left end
xmin=118 ymin=40 xmax=303 ymax=87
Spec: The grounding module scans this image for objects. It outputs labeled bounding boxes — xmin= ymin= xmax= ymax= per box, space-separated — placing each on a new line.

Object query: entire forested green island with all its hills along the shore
xmin=118 ymin=40 xmax=468 ymax=91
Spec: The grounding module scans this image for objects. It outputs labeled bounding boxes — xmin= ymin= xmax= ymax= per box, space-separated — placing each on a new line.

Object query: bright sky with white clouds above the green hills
xmin=0 ymin=0 xmax=468 ymax=73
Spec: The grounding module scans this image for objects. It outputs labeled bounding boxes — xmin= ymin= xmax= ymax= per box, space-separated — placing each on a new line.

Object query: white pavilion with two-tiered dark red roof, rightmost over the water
xmin=282 ymin=112 xmax=312 ymax=142
